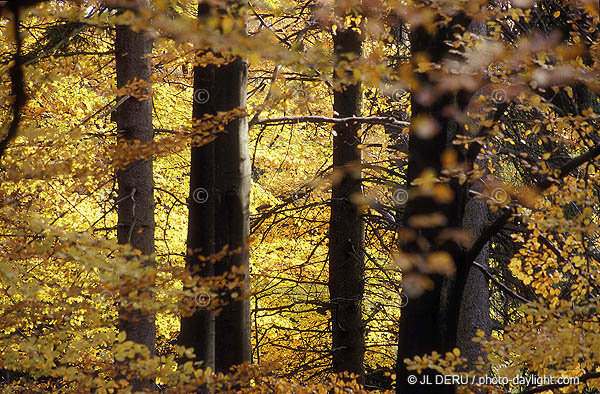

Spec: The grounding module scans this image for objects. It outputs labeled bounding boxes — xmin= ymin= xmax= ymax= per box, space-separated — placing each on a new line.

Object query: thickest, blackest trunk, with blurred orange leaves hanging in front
xmin=396 ymin=15 xmax=468 ymax=394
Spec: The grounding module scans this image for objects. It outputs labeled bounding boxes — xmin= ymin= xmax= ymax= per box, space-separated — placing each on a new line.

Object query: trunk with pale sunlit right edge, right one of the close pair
xmin=214 ymin=53 xmax=251 ymax=371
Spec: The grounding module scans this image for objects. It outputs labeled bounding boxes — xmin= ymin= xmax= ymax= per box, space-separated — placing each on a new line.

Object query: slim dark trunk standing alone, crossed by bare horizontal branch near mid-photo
xmin=329 ymin=23 xmax=365 ymax=381
